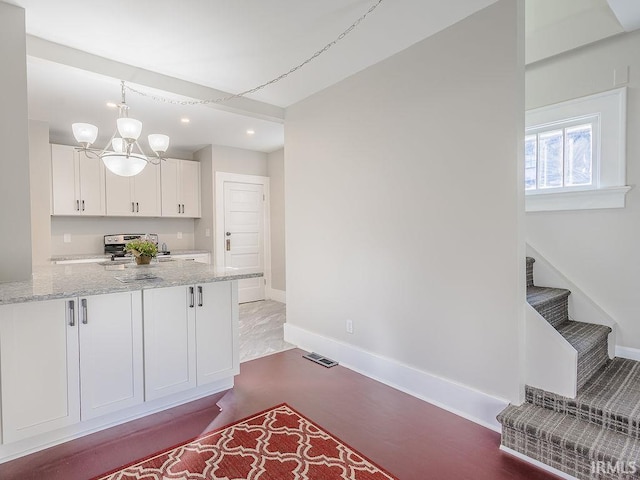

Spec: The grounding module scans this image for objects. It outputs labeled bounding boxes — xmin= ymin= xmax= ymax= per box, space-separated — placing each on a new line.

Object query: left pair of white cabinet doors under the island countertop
xmin=0 ymin=291 xmax=143 ymax=443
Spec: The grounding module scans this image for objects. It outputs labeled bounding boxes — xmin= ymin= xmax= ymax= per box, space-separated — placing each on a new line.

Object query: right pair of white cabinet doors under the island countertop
xmin=143 ymin=282 xmax=239 ymax=400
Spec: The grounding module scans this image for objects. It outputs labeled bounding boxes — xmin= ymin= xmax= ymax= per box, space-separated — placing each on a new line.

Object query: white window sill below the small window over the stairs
xmin=524 ymin=186 xmax=631 ymax=212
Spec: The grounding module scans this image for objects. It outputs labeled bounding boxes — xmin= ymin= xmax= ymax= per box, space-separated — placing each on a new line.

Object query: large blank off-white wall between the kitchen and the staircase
xmin=285 ymin=0 xmax=524 ymax=401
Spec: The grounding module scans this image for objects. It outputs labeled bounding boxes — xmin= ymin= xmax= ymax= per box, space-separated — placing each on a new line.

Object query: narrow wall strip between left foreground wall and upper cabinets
xmin=29 ymin=120 xmax=51 ymax=266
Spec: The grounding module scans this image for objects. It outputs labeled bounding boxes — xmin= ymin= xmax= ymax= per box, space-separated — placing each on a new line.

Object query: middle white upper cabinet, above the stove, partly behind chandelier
xmin=106 ymin=164 xmax=161 ymax=217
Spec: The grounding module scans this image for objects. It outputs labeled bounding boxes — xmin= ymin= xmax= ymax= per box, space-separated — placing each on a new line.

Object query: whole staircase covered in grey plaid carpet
xmin=498 ymin=258 xmax=640 ymax=480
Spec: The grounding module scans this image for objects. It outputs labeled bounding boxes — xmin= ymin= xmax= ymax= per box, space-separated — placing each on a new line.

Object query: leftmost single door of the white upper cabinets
xmin=51 ymin=145 xmax=80 ymax=215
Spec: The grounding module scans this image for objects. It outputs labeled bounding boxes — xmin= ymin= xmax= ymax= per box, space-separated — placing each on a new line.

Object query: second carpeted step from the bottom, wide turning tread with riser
xmin=526 ymin=357 xmax=640 ymax=440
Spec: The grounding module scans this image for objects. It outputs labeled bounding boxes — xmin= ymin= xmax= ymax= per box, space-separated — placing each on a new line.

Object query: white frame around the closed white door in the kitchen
xmin=213 ymin=172 xmax=271 ymax=299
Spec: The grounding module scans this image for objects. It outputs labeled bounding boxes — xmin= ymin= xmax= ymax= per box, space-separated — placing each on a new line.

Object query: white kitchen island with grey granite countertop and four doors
xmin=0 ymin=260 xmax=262 ymax=462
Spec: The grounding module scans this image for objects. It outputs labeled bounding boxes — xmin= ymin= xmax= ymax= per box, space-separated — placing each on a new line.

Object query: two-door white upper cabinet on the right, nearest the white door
xmin=161 ymin=158 xmax=201 ymax=218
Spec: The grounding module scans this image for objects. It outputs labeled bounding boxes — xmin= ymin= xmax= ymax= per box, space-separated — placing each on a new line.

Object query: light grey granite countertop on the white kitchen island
xmin=0 ymin=260 xmax=263 ymax=305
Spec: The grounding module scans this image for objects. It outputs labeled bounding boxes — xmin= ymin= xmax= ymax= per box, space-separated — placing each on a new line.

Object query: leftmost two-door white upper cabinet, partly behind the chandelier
xmin=51 ymin=145 xmax=105 ymax=215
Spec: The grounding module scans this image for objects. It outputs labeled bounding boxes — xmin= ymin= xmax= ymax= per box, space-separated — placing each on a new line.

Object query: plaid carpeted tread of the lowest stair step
xmin=497 ymin=403 xmax=640 ymax=466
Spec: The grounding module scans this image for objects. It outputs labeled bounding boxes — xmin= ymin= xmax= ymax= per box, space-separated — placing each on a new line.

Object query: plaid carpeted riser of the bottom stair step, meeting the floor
xmin=502 ymin=426 xmax=640 ymax=480
